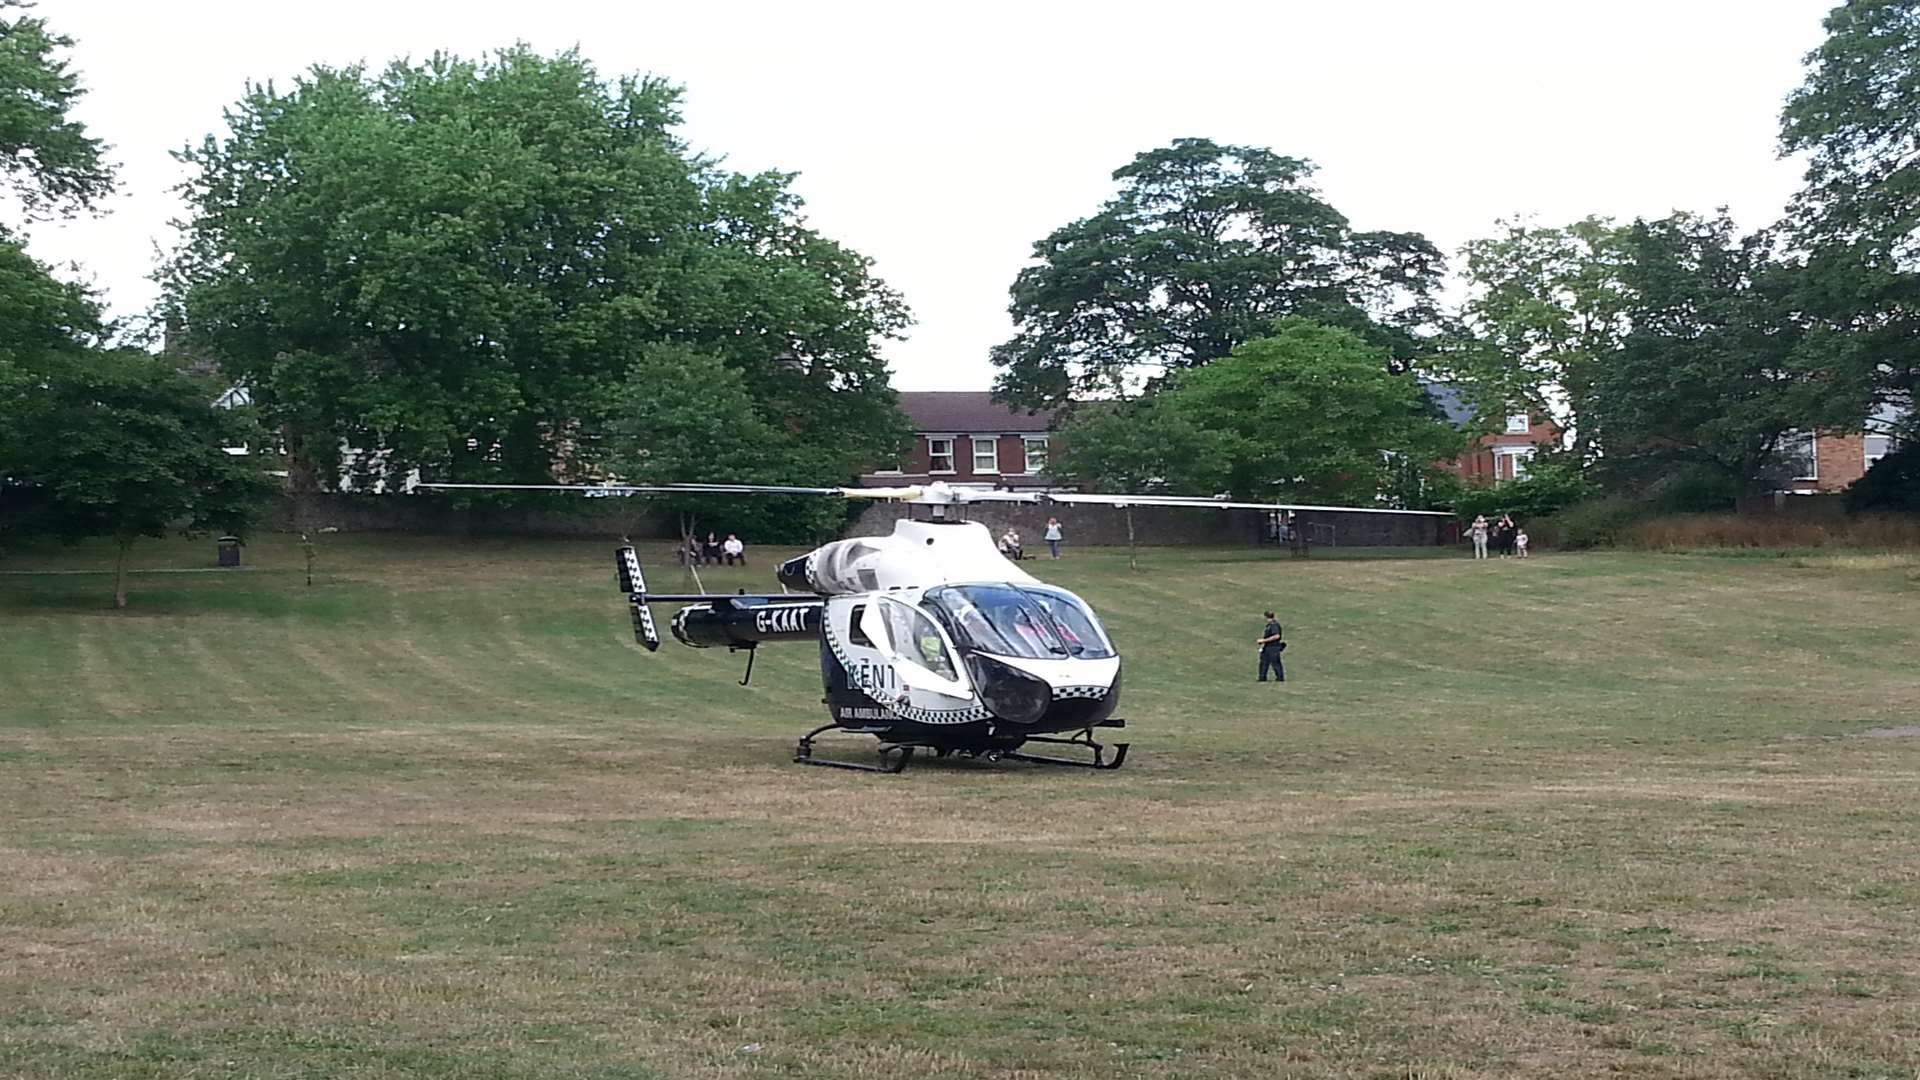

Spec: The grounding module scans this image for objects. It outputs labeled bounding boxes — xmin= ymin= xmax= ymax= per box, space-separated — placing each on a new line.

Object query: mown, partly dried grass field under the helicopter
xmin=0 ymin=536 xmax=1920 ymax=1078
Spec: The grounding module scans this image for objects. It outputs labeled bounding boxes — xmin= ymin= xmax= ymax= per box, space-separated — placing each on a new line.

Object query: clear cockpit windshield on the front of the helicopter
xmin=925 ymin=584 xmax=1114 ymax=659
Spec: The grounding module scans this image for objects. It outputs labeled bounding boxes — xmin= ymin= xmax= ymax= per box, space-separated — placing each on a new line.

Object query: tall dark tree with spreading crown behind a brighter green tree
xmin=993 ymin=138 xmax=1442 ymax=407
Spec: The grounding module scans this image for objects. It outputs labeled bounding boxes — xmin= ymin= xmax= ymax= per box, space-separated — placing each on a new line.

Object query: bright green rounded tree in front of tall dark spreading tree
xmin=1062 ymin=319 xmax=1459 ymax=505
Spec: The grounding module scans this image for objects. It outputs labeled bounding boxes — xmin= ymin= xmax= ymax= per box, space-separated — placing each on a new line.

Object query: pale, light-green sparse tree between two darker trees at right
xmin=1436 ymin=217 xmax=1626 ymax=459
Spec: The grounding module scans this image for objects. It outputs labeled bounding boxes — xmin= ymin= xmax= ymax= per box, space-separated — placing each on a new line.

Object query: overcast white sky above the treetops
xmin=33 ymin=0 xmax=1834 ymax=390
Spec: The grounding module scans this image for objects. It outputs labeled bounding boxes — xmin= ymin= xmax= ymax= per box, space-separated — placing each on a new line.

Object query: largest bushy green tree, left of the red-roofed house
xmin=167 ymin=48 xmax=906 ymax=486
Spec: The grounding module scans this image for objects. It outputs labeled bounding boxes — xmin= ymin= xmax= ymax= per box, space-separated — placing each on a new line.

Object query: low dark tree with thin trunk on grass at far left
xmin=0 ymin=350 xmax=275 ymax=607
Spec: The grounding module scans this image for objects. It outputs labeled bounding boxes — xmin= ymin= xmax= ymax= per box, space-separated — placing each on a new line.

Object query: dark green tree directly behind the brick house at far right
xmin=1588 ymin=213 xmax=1870 ymax=492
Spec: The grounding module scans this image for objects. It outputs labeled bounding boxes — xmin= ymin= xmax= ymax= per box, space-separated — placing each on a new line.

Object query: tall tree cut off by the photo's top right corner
xmin=1780 ymin=0 xmax=1920 ymax=434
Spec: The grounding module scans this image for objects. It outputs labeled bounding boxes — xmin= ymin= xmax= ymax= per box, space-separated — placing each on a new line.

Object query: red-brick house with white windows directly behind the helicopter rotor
xmin=860 ymin=390 xmax=1054 ymax=488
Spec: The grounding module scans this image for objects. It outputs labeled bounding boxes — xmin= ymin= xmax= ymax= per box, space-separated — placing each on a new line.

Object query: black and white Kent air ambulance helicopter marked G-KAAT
xmin=419 ymin=482 xmax=1432 ymax=773
